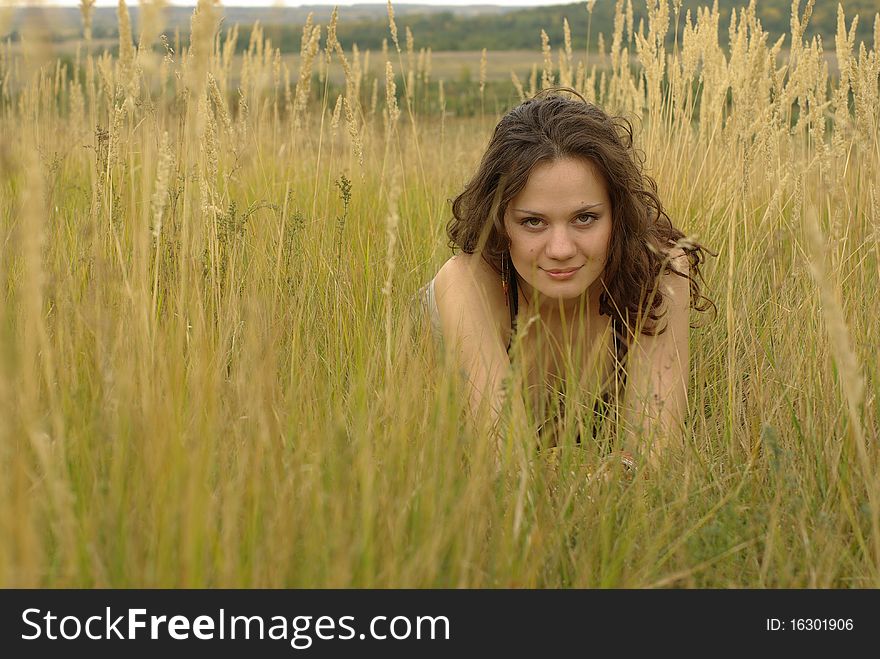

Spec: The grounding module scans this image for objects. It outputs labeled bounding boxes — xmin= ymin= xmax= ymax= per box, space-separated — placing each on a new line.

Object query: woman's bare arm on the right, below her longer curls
xmin=623 ymin=250 xmax=690 ymax=467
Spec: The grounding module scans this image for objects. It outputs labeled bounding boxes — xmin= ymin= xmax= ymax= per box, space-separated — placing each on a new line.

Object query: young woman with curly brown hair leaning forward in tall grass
xmin=423 ymin=88 xmax=711 ymax=474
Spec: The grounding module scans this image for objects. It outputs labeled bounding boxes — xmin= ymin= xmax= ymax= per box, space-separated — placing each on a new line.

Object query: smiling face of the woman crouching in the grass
xmin=504 ymin=158 xmax=612 ymax=310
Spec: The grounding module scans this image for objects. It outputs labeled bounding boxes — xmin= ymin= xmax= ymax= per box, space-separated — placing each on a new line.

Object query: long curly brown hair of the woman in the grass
xmin=446 ymin=87 xmax=717 ymax=336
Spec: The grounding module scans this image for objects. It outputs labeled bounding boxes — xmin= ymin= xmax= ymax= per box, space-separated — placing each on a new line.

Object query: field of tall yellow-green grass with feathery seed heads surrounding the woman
xmin=0 ymin=2 xmax=880 ymax=588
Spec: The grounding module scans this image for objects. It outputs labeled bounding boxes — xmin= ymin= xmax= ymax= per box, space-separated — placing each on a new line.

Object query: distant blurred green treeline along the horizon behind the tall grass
xmin=7 ymin=0 xmax=880 ymax=55
